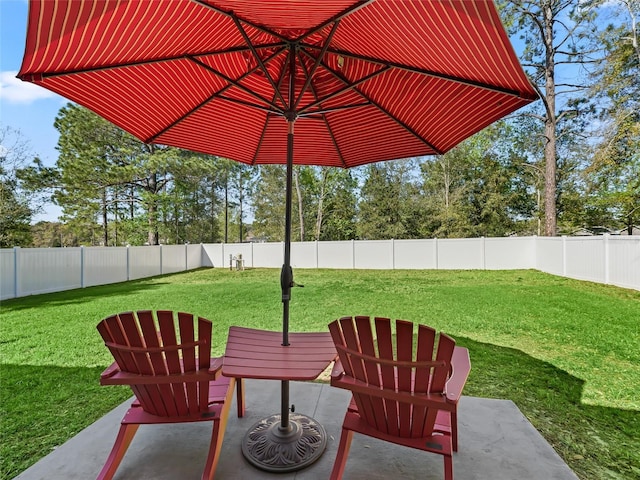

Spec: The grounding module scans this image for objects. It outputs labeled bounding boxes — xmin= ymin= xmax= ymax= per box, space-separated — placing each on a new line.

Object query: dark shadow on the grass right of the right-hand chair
xmin=456 ymin=337 xmax=640 ymax=479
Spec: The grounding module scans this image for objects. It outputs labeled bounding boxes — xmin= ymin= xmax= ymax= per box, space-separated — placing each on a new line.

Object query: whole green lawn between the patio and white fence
xmin=0 ymin=269 xmax=640 ymax=480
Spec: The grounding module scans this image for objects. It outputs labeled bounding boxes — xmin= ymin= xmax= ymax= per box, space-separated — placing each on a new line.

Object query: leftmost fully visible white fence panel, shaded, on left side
xmin=17 ymin=247 xmax=82 ymax=296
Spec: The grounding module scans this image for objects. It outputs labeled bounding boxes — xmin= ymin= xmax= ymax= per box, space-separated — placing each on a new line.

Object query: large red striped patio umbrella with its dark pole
xmin=18 ymin=0 xmax=536 ymax=469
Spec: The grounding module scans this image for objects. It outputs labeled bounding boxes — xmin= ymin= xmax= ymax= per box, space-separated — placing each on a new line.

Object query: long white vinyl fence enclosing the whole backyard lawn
xmin=0 ymin=235 xmax=640 ymax=300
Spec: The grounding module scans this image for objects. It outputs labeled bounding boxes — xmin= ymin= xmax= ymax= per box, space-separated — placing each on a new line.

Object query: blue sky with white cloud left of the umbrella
xmin=0 ymin=0 xmax=66 ymax=221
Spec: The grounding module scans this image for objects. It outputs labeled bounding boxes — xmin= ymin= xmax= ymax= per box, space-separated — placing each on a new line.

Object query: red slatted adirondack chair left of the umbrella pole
xmin=97 ymin=310 xmax=244 ymax=480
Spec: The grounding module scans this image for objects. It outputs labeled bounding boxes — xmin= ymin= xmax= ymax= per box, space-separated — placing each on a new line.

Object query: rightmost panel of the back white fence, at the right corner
xmin=484 ymin=237 xmax=536 ymax=270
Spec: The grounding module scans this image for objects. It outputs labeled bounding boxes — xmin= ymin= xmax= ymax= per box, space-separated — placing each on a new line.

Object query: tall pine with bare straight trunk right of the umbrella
xmin=501 ymin=0 xmax=598 ymax=236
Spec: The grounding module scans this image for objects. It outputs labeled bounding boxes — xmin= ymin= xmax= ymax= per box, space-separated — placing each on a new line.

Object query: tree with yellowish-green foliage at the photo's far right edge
xmin=587 ymin=0 xmax=640 ymax=234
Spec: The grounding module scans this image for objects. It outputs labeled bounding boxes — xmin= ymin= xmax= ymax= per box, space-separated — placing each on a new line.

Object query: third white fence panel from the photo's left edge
xmin=82 ymin=247 xmax=128 ymax=287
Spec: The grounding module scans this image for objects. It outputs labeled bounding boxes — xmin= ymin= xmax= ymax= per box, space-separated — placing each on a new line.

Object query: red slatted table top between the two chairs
xmin=222 ymin=327 xmax=337 ymax=381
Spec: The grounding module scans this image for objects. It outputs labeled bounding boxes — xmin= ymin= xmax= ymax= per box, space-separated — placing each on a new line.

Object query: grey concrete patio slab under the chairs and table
xmin=16 ymin=380 xmax=578 ymax=480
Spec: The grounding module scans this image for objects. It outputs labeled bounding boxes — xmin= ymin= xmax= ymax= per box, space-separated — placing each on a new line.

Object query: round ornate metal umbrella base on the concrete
xmin=242 ymin=413 xmax=327 ymax=472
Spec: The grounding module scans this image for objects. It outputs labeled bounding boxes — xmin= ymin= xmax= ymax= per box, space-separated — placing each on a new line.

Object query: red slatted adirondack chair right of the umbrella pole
xmin=329 ymin=317 xmax=471 ymax=480
